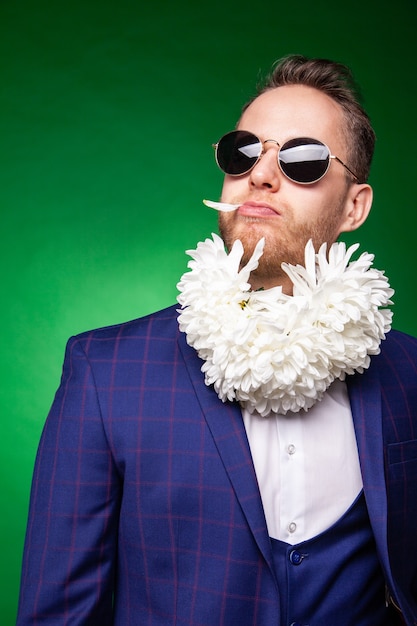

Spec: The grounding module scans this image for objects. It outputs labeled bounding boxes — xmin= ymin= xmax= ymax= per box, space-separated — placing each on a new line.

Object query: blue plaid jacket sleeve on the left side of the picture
xmin=17 ymin=338 xmax=121 ymax=626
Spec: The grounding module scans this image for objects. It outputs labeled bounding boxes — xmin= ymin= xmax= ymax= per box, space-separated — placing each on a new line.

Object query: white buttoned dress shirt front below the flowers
xmin=243 ymin=380 xmax=362 ymax=544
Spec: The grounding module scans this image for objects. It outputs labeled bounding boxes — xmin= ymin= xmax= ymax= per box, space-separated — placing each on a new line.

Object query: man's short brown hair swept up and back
xmin=244 ymin=55 xmax=375 ymax=182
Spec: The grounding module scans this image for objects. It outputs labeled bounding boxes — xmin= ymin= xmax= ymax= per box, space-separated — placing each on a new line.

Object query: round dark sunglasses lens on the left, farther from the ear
xmin=216 ymin=130 xmax=262 ymax=176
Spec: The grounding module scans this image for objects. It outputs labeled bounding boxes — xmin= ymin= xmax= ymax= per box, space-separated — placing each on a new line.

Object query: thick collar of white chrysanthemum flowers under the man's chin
xmin=178 ymin=234 xmax=394 ymax=416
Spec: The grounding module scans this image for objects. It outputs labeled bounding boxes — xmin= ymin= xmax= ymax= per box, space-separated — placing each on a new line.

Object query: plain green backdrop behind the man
xmin=0 ymin=0 xmax=417 ymax=626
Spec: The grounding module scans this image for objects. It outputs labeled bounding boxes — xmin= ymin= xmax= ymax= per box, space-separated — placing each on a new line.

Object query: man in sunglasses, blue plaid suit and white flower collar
xmin=18 ymin=56 xmax=417 ymax=626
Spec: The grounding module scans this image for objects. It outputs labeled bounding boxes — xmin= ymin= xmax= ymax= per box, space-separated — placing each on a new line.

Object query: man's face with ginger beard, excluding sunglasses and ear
xmin=219 ymin=85 xmax=360 ymax=292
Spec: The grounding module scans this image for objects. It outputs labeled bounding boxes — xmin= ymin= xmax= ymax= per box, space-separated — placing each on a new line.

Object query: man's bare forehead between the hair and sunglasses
xmin=238 ymin=85 xmax=344 ymax=145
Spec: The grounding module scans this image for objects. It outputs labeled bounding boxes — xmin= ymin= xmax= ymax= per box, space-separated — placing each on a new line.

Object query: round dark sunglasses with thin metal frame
xmin=213 ymin=130 xmax=359 ymax=185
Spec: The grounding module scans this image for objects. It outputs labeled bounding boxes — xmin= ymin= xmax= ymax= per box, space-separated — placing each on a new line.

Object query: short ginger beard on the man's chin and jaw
xmin=219 ymin=198 xmax=345 ymax=288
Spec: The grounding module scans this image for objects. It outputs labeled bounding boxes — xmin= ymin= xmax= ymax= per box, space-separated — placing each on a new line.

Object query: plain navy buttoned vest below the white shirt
xmin=271 ymin=493 xmax=393 ymax=626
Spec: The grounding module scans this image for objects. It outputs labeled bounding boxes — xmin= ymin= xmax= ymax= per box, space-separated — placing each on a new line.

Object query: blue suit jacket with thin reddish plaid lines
xmin=17 ymin=307 xmax=417 ymax=626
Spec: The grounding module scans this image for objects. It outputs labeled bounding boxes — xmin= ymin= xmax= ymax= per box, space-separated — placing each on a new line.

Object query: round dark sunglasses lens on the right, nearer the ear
xmin=278 ymin=137 xmax=330 ymax=183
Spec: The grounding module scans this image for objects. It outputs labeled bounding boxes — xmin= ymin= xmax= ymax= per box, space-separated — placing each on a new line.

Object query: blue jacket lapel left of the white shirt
xmin=179 ymin=333 xmax=273 ymax=571
